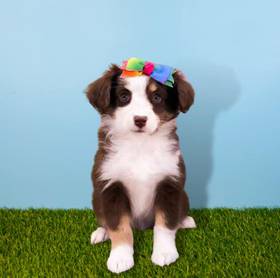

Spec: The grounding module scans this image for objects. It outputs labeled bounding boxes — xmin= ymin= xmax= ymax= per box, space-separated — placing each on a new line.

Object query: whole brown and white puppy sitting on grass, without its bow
xmin=86 ymin=65 xmax=195 ymax=273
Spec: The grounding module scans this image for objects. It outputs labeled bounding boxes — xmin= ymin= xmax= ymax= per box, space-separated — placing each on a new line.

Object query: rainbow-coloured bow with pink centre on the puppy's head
xmin=121 ymin=57 xmax=175 ymax=87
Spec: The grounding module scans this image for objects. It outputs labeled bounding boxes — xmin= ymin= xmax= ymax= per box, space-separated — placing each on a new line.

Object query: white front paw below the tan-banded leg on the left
xmin=107 ymin=245 xmax=134 ymax=273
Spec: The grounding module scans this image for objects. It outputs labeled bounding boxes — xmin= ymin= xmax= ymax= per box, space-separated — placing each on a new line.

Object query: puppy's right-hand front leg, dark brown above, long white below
xmin=152 ymin=179 xmax=188 ymax=266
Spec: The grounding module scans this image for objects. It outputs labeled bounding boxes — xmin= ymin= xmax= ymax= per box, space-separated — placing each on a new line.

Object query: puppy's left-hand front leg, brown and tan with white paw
xmin=102 ymin=182 xmax=134 ymax=273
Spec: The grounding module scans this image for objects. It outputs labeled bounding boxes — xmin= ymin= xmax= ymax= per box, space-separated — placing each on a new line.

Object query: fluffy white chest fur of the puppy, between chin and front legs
xmin=100 ymin=122 xmax=180 ymax=217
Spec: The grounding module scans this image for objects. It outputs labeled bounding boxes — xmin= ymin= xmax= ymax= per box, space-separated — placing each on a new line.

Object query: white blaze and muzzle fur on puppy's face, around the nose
xmin=113 ymin=75 xmax=160 ymax=133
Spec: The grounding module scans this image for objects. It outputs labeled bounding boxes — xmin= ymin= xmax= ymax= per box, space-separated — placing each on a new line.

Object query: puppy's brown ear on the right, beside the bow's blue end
xmin=173 ymin=70 xmax=194 ymax=113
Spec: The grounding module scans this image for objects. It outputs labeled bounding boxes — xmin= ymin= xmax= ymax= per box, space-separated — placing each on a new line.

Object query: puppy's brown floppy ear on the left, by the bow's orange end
xmin=86 ymin=65 xmax=122 ymax=114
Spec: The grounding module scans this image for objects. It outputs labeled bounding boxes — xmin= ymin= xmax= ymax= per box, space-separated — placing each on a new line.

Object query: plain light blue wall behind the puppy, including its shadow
xmin=0 ymin=0 xmax=280 ymax=208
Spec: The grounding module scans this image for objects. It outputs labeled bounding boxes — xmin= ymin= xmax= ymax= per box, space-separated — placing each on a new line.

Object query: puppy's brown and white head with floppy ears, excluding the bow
xmin=86 ymin=65 xmax=194 ymax=134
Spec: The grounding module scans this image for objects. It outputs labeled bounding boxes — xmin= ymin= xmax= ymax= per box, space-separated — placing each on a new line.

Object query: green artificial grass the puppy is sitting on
xmin=0 ymin=209 xmax=280 ymax=278
